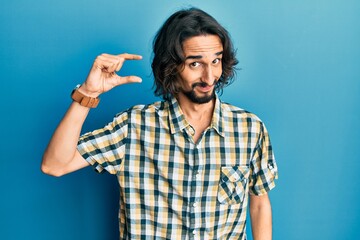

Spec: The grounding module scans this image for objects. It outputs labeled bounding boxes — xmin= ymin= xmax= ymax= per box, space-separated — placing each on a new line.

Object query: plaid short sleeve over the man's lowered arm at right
xmin=249 ymin=123 xmax=278 ymax=195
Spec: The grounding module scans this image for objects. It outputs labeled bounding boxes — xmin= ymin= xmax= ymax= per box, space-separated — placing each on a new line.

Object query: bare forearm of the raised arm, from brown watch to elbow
xmin=41 ymin=102 xmax=89 ymax=175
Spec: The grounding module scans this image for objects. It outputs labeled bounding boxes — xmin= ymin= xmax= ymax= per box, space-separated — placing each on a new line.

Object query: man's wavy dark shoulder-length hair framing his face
xmin=151 ymin=8 xmax=238 ymax=100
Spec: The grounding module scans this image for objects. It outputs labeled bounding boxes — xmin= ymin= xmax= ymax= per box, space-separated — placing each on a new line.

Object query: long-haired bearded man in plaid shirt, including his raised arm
xmin=42 ymin=8 xmax=277 ymax=240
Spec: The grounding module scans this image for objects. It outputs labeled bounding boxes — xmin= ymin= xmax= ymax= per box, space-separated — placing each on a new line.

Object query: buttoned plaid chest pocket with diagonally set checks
xmin=217 ymin=166 xmax=249 ymax=204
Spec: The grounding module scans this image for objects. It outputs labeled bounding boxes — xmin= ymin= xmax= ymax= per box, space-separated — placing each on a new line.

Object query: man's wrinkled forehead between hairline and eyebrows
xmin=183 ymin=35 xmax=223 ymax=58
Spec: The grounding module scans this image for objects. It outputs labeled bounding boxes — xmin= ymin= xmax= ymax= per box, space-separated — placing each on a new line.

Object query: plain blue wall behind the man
xmin=0 ymin=0 xmax=360 ymax=240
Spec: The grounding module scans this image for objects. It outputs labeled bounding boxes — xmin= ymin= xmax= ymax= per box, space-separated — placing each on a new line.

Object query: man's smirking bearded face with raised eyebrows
xmin=178 ymin=35 xmax=223 ymax=104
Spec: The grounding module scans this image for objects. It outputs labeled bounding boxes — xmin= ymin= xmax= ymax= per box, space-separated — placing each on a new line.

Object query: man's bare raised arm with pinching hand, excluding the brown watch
xmin=41 ymin=54 xmax=141 ymax=176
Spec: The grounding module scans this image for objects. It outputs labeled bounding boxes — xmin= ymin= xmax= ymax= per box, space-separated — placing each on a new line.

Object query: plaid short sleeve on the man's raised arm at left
xmin=77 ymin=112 xmax=128 ymax=174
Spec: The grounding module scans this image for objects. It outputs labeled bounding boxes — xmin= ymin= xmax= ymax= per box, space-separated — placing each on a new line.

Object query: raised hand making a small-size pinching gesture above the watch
xmin=79 ymin=53 xmax=142 ymax=98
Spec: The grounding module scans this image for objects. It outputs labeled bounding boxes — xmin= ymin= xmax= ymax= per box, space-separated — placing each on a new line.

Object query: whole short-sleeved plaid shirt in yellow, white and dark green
xmin=78 ymin=95 xmax=277 ymax=240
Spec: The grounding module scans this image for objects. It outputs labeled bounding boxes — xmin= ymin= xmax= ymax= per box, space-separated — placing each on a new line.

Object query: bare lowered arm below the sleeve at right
xmin=250 ymin=194 xmax=272 ymax=240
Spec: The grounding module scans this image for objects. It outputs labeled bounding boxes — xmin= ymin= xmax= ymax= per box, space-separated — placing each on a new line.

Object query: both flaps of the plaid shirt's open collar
xmin=169 ymin=95 xmax=224 ymax=136
